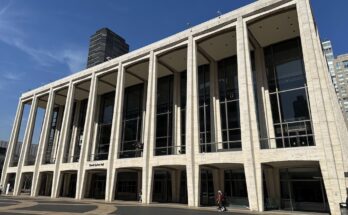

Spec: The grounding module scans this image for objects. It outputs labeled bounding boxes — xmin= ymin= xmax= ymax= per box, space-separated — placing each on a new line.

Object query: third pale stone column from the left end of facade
xmin=31 ymin=88 xmax=55 ymax=196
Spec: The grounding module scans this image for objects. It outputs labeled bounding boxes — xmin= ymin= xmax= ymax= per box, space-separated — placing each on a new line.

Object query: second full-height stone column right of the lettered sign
xmin=142 ymin=51 xmax=157 ymax=204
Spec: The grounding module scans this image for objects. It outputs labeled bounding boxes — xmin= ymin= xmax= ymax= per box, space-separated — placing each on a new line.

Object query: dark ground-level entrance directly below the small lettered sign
xmin=85 ymin=170 xmax=106 ymax=199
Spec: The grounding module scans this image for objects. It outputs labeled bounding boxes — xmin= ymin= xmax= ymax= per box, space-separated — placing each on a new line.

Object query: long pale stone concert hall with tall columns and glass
xmin=1 ymin=0 xmax=348 ymax=214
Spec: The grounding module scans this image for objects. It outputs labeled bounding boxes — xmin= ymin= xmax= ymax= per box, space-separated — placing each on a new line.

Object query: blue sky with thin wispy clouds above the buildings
xmin=0 ymin=0 xmax=348 ymax=140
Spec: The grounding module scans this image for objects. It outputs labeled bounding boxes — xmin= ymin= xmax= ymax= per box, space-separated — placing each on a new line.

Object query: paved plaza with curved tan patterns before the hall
xmin=0 ymin=196 xmax=330 ymax=215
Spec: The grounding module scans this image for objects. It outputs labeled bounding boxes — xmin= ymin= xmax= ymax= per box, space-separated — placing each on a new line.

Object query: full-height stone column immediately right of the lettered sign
xmin=105 ymin=63 xmax=125 ymax=202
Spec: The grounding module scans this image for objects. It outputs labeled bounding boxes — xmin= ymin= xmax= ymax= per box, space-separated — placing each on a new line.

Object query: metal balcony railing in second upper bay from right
xmin=199 ymin=140 xmax=242 ymax=153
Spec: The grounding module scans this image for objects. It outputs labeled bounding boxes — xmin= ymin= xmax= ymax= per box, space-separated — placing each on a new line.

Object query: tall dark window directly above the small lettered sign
xmin=94 ymin=92 xmax=115 ymax=160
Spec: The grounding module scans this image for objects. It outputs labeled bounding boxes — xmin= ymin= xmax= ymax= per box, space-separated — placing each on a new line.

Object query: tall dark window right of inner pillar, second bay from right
xmin=218 ymin=56 xmax=242 ymax=150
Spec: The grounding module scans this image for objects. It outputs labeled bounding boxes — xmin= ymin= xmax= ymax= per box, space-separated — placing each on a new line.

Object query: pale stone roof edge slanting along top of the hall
xmin=21 ymin=0 xmax=294 ymax=99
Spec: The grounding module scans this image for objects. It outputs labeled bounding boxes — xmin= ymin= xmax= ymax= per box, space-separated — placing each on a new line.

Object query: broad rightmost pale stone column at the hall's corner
xmin=297 ymin=0 xmax=345 ymax=214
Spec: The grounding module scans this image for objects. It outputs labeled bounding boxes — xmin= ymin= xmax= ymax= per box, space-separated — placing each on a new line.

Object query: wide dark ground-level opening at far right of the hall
xmin=263 ymin=164 xmax=330 ymax=212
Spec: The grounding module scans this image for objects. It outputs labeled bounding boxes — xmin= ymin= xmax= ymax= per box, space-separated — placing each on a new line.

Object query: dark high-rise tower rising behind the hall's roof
xmin=87 ymin=28 xmax=129 ymax=68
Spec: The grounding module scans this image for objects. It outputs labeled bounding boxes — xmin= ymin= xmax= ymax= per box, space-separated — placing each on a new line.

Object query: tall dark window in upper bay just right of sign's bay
xmin=119 ymin=84 xmax=144 ymax=158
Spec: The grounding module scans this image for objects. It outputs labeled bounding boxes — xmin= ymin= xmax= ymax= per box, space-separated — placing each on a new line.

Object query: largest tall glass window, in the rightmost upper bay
xmin=264 ymin=38 xmax=315 ymax=148
